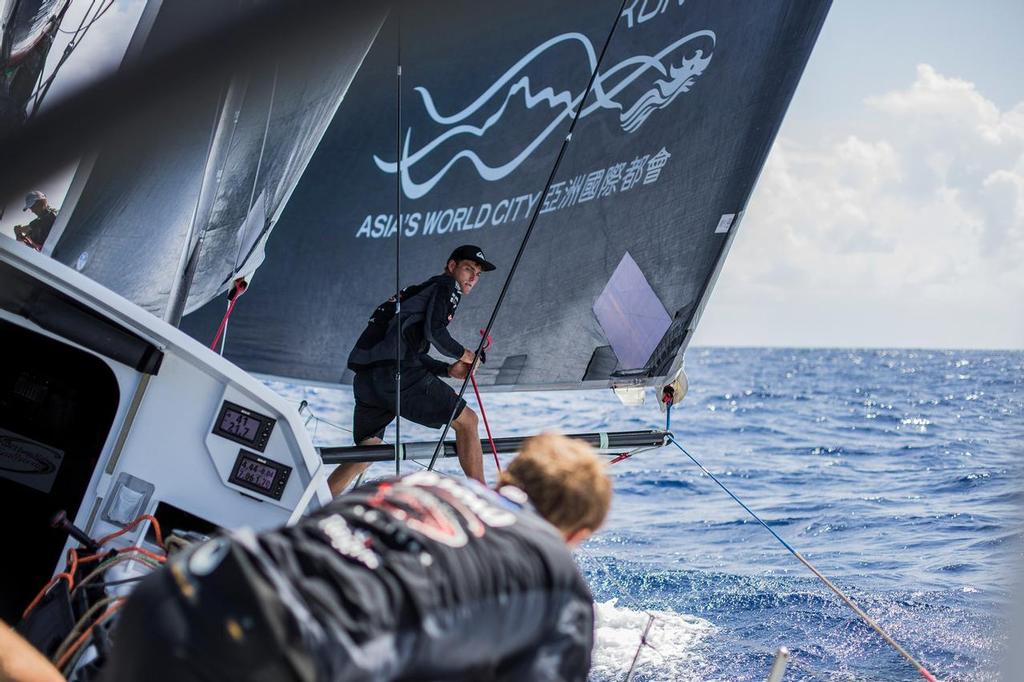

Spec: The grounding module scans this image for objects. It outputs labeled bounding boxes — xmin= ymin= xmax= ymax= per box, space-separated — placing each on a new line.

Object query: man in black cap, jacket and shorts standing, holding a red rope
xmin=328 ymin=244 xmax=495 ymax=495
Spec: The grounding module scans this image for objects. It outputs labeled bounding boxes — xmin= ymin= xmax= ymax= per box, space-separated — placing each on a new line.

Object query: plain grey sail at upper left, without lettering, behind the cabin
xmin=53 ymin=0 xmax=386 ymax=316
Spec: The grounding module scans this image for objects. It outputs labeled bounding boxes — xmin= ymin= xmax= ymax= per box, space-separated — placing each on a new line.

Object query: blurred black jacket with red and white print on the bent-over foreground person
xmin=247 ymin=471 xmax=594 ymax=682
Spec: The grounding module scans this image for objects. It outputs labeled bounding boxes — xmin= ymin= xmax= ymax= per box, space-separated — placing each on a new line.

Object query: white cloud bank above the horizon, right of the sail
xmin=698 ymin=65 xmax=1024 ymax=348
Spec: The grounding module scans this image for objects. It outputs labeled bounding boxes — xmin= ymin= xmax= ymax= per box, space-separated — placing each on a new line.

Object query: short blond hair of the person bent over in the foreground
xmin=498 ymin=433 xmax=611 ymax=535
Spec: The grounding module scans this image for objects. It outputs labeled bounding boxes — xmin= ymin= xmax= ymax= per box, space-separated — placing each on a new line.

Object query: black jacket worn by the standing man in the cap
xmin=348 ymin=274 xmax=466 ymax=376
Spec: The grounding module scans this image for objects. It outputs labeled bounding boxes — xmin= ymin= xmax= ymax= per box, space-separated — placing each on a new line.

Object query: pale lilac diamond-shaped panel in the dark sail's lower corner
xmin=594 ymin=253 xmax=672 ymax=369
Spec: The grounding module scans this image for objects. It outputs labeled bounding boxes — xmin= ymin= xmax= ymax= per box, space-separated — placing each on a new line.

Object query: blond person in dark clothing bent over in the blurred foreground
xmin=100 ymin=434 xmax=611 ymax=682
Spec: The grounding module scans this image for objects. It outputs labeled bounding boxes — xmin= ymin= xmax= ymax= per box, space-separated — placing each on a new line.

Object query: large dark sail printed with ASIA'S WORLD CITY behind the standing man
xmin=183 ymin=0 xmax=829 ymax=389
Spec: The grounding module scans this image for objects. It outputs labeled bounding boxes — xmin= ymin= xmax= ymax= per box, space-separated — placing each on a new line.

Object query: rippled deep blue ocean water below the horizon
xmin=271 ymin=348 xmax=1024 ymax=681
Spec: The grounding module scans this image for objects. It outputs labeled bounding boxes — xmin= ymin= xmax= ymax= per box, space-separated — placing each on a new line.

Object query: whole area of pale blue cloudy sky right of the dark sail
xmin=694 ymin=0 xmax=1024 ymax=348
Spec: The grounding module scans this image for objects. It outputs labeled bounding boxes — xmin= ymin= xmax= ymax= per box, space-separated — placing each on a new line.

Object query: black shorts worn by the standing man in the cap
xmin=352 ymin=366 xmax=466 ymax=444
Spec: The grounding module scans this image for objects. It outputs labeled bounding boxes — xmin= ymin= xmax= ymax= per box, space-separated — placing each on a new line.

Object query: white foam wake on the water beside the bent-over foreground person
xmin=590 ymin=599 xmax=715 ymax=681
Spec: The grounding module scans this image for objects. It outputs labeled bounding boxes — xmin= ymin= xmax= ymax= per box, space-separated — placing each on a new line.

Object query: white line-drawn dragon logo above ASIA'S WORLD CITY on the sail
xmin=374 ymin=30 xmax=716 ymax=199
